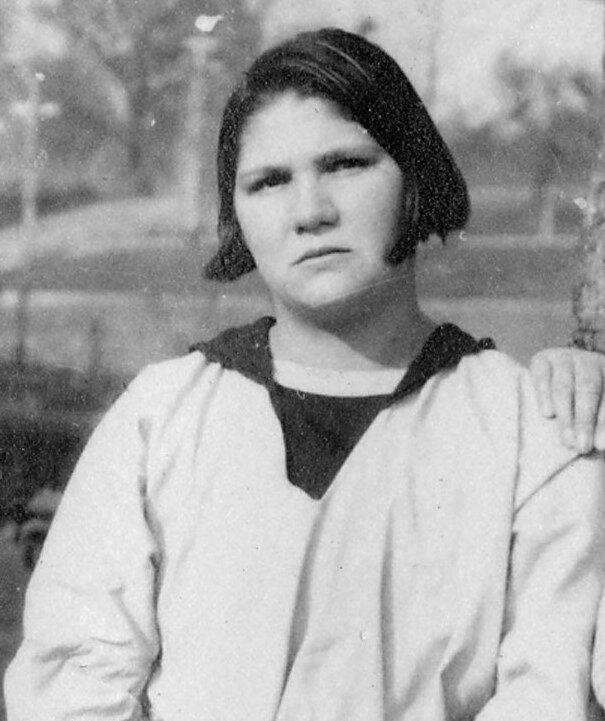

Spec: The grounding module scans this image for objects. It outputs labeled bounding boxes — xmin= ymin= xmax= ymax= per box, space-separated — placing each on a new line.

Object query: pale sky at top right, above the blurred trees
xmin=266 ymin=0 xmax=605 ymax=121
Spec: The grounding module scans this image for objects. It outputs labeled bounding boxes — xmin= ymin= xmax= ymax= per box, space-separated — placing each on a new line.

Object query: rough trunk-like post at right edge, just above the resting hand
xmin=573 ymin=0 xmax=605 ymax=352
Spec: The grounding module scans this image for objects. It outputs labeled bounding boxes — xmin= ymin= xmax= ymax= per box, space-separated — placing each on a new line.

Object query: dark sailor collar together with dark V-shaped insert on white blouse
xmin=192 ymin=317 xmax=494 ymax=500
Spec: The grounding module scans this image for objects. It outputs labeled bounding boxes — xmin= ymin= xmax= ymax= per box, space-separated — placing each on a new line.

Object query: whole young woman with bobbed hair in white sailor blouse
xmin=6 ymin=29 xmax=605 ymax=721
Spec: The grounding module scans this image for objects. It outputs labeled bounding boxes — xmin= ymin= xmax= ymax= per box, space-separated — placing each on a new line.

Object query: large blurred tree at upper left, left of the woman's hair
xmin=34 ymin=0 xmax=259 ymax=194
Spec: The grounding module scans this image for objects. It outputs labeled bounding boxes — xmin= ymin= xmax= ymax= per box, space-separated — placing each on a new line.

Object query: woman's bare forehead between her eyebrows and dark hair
xmin=238 ymin=92 xmax=377 ymax=169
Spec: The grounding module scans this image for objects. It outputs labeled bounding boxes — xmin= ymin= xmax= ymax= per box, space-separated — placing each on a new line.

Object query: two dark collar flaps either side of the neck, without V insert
xmin=190 ymin=316 xmax=495 ymax=400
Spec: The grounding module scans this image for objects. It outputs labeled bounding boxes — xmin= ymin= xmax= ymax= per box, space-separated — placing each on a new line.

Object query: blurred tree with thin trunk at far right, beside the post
xmin=499 ymin=53 xmax=600 ymax=236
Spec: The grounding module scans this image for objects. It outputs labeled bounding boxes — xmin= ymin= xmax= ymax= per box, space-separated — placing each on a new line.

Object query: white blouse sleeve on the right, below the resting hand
xmin=476 ymin=376 xmax=605 ymax=721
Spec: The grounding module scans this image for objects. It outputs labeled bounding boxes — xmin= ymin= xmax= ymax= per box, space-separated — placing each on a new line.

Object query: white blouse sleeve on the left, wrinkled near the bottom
xmin=5 ymin=380 xmax=159 ymax=721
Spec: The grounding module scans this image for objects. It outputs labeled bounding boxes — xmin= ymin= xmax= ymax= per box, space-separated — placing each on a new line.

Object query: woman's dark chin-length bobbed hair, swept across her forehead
xmin=206 ymin=28 xmax=470 ymax=281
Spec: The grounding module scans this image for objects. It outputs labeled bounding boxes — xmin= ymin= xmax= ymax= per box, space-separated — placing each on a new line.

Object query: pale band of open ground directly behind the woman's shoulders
xmin=0 ymin=296 xmax=571 ymax=377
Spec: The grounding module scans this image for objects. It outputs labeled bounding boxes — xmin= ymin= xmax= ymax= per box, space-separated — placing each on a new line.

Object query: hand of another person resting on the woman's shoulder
xmin=530 ymin=348 xmax=605 ymax=453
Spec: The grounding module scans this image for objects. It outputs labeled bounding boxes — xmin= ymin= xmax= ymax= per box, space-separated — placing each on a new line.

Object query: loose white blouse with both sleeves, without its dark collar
xmin=5 ymin=351 xmax=605 ymax=721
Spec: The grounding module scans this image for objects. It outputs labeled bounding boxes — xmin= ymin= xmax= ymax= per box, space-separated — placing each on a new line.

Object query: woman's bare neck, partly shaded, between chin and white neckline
xmin=271 ymin=261 xmax=435 ymax=370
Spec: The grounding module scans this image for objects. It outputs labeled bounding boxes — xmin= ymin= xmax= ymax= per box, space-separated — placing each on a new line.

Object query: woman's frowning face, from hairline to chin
xmin=234 ymin=92 xmax=403 ymax=309
